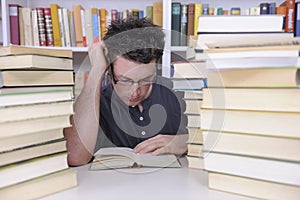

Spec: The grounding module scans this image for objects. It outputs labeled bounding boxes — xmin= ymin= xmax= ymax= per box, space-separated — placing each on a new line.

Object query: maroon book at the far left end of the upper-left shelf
xmin=8 ymin=4 xmax=21 ymax=45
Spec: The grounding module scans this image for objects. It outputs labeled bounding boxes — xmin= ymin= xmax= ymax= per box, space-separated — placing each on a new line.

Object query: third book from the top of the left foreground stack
xmin=0 ymin=69 xmax=74 ymax=87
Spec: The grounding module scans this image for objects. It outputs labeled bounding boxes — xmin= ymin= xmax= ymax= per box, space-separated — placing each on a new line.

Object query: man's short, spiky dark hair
xmin=103 ymin=18 xmax=165 ymax=64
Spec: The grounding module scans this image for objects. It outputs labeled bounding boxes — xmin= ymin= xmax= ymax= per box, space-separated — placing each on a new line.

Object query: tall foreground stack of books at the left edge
xmin=0 ymin=46 xmax=77 ymax=199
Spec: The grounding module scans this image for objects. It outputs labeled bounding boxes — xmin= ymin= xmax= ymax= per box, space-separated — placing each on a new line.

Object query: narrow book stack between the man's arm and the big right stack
xmin=172 ymin=62 xmax=207 ymax=169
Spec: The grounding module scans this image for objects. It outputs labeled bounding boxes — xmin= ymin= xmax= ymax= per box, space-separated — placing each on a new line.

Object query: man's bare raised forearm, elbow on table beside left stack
xmin=64 ymin=69 xmax=103 ymax=166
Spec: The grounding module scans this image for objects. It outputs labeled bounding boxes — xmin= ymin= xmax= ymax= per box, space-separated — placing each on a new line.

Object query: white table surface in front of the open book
xmin=43 ymin=159 xmax=250 ymax=200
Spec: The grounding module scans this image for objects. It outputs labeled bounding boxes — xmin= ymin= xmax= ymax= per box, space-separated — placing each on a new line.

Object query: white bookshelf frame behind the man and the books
xmin=0 ymin=0 xmax=290 ymax=77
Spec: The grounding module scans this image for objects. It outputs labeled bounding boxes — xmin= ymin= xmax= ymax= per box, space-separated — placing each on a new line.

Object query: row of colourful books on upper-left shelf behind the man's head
xmin=9 ymin=2 xmax=162 ymax=47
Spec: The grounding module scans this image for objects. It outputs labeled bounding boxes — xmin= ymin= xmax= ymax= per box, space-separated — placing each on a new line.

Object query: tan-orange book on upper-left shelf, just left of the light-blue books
xmin=72 ymin=5 xmax=83 ymax=47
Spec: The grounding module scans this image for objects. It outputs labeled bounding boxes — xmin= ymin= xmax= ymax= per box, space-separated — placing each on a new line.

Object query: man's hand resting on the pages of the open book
xmin=133 ymin=134 xmax=188 ymax=155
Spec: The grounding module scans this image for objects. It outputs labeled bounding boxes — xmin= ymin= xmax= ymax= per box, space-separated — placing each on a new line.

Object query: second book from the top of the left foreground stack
xmin=0 ymin=54 xmax=73 ymax=70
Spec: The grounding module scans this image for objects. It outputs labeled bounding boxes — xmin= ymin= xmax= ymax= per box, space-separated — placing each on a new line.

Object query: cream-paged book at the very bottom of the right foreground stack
xmin=208 ymin=172 xmax=300 ymax=200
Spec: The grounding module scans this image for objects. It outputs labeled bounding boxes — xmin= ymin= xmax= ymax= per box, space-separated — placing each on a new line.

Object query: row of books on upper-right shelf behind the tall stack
xmin=171 ymin=0 xmax=299 ymax=46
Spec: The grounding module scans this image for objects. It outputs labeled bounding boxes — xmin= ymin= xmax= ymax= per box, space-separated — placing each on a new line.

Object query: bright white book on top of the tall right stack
xmin=198 ymin=15 xmax=283 ymax=34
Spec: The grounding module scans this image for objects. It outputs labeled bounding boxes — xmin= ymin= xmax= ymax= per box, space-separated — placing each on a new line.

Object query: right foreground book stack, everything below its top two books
xmin=201 ymin=42 xmax=300 ymax=199
